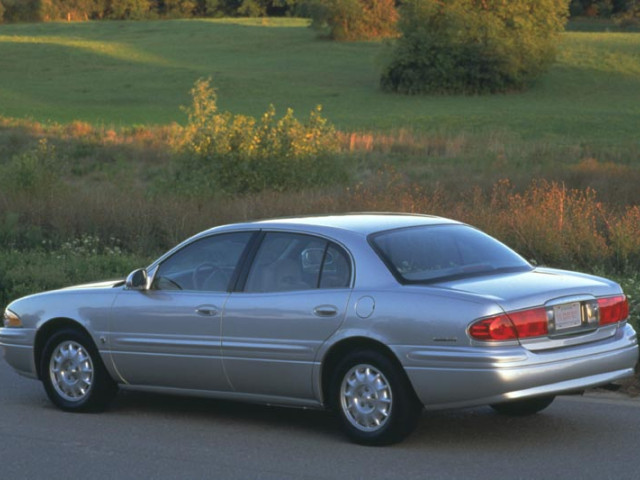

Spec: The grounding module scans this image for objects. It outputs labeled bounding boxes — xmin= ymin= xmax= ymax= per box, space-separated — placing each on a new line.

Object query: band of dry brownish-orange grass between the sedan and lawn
xmin=0 ymin=118 xmax=640 ymax=278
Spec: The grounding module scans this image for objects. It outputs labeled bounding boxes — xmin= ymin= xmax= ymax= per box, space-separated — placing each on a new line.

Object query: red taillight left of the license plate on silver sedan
xmin=469 ymin=308 xmax=549 ymax=341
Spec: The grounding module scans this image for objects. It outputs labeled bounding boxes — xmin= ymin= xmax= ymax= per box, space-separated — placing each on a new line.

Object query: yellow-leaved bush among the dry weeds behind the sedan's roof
xmin=176 ymin=79 xmax=345 ymax=195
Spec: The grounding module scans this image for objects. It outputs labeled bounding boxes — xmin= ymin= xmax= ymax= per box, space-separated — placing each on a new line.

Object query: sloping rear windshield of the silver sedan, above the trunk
xmin=370 ymin=225 xmax=532 ymax=283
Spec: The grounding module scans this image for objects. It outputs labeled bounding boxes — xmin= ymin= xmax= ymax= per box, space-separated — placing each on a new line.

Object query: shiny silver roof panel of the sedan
xmin=214 ymin=213 xmax=459 ymax=235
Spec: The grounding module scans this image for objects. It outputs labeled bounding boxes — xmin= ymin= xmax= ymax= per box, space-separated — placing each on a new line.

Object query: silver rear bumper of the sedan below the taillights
xmin=396 ymin=325 xmax=638 ymax=409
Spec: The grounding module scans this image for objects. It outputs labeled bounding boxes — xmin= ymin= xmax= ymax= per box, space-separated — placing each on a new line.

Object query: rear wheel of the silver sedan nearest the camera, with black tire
xmin=329 ymin=350 xmax=423 ymax=445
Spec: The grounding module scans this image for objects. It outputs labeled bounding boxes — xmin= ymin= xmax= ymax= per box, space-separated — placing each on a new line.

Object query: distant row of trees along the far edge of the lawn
xmin=0 ymin=0 xmax=640 ymax=22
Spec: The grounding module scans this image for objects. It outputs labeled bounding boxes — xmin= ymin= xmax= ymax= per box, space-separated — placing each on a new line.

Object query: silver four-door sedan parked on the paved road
xmin=0 ymin=215 xmax=638 ymax=445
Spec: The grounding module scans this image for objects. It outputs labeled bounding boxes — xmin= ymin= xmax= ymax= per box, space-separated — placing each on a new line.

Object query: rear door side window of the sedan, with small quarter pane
xmin=245 ymin=232 xmax=350 ymax=292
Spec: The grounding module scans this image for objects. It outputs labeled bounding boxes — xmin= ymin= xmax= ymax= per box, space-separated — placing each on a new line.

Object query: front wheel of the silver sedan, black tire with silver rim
xmin=40 ymin=328 xmax=118 ymax=412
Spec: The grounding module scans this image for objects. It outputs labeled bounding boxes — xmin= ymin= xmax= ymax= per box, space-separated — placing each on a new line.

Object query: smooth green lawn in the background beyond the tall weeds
xmin=0 ymin=19 xmax=640 ymax=145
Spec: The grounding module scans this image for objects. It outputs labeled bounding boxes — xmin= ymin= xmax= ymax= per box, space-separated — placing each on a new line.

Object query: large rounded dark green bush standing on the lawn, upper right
xmin=380 ymin=0 xmax=568 ymax=94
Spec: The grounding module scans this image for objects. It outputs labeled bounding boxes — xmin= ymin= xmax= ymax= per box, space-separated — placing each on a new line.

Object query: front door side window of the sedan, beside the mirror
xmin=151 ymin=232 xmax=252 ymax=292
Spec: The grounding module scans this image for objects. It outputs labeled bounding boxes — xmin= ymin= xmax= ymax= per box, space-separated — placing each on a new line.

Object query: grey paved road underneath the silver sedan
xmin=0 ymin=360 xmax=640 ymax=480
